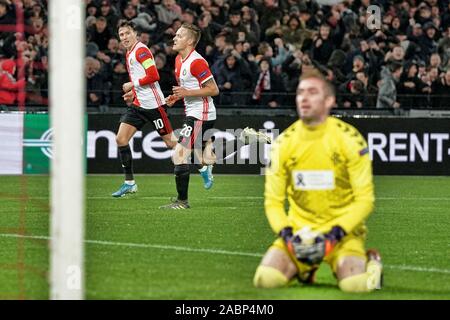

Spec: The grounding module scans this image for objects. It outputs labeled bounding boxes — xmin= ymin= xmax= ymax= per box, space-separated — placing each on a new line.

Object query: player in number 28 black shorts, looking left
xmin=161 ymin=23 xmax=219 ymax=209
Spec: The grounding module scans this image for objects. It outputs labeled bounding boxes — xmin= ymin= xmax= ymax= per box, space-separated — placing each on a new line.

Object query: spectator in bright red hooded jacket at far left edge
xmin=0 ymin=59 xmax=26 ymax=105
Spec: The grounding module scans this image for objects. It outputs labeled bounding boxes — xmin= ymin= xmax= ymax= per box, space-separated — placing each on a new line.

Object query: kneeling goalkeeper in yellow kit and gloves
xmin=253 ymin=71 xmax=382 ymax=292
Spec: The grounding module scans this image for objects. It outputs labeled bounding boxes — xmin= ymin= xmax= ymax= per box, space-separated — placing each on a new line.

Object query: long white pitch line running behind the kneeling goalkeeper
xmin=0 ymin=233 xmax=450 ymax=274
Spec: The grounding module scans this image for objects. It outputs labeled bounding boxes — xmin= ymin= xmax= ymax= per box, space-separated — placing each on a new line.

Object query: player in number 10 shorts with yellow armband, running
xmin=112 ymin=21 xmax=177 ymax=197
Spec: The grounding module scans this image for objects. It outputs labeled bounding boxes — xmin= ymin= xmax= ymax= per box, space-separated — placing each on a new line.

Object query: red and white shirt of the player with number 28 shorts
xmin=175 ymin=50 xmax=216 ymax=121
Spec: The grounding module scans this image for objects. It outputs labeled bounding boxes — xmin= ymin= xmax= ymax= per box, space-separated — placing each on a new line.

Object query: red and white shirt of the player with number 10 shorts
xmin=126 ymin=42 xmax=165 ymax=109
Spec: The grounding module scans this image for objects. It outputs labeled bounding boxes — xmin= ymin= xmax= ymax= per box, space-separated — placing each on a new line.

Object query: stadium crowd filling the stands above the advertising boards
xmin=0 ymin=0 xmax=450 ymax=109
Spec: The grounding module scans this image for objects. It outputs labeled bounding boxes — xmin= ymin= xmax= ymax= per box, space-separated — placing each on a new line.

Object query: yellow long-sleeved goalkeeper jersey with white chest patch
xmin=264 ymin=117 xmax=374 ymax=234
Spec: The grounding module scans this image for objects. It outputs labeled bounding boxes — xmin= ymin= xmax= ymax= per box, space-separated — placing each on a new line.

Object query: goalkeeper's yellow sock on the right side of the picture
xmin=339 ymin=261 xmax=382 ymax=292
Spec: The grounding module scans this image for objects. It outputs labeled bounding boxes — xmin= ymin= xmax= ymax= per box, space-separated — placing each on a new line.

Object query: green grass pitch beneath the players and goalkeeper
xmin=0 ymin=174 xmax=450 ymax=299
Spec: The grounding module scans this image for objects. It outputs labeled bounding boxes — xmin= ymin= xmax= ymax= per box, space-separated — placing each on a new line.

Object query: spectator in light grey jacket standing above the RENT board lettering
xmin=376 ymin=61 xmax=403 ymax=109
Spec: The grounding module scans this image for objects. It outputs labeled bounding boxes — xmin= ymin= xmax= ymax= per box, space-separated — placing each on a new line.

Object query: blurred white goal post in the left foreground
xmin=49 ymin=0 xmax=86 ymax=300
